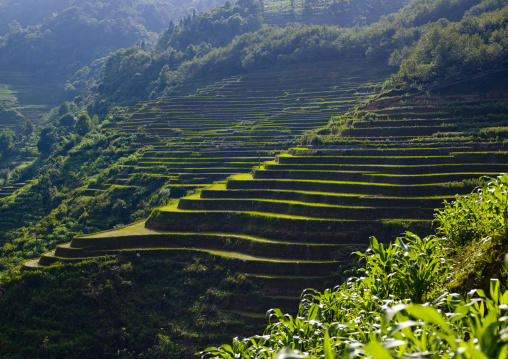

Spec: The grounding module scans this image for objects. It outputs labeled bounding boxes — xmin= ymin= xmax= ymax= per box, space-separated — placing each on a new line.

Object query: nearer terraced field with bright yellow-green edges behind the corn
xmin=32 ymin=142 xmax=508 ymax=313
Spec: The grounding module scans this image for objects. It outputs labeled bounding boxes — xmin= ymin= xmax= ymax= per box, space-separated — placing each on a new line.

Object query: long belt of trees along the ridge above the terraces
xmin=87 ymin=0 xmax=508 ymax=113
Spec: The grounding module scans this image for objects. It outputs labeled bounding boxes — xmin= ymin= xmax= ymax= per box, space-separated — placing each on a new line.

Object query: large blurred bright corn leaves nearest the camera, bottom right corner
xmin=338 ymin=279 xmax=508 ymax=359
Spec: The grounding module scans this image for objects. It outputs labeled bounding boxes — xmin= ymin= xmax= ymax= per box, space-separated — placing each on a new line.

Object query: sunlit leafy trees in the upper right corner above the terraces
xmin=391 ymin=7 xmax=508 ymax=85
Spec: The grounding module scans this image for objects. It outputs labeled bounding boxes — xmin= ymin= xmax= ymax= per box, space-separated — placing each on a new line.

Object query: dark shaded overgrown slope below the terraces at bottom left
xmin=0 ymin=251 xmax=260 ymax=358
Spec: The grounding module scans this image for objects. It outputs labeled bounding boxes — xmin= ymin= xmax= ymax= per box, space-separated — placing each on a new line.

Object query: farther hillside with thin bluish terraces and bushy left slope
xmin=0 ymin=62 xmax=388 ymax=276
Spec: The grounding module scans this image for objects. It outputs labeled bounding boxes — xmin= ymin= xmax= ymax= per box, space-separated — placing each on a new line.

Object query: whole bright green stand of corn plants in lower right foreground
xmin=201 ymin=175 xmax=508 ymax=359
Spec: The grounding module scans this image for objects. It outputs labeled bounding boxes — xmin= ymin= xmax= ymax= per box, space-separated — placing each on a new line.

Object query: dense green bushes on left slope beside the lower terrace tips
xmin=0 ymin=127 xmax=144 ymax=278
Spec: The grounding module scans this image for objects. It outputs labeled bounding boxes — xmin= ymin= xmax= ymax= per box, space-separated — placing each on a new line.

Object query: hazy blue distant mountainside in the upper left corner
xmin=0 ymin=0 xmax=230 ymax=148
